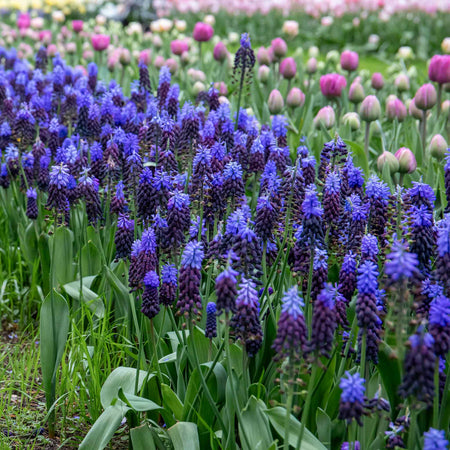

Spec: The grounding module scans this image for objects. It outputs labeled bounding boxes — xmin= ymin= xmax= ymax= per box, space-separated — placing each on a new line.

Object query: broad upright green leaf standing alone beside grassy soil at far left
xmin=40 ymin=289 xmax=70 ymax=414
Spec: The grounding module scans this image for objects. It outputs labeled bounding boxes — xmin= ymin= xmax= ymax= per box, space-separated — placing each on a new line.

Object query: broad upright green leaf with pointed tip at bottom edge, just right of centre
xmin=239 ymin=395 xmax=273 ymax=450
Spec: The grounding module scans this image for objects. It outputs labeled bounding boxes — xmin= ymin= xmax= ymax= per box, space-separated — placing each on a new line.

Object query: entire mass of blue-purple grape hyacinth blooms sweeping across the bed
xmin=0 ymin=40 xmax=450 ymax=438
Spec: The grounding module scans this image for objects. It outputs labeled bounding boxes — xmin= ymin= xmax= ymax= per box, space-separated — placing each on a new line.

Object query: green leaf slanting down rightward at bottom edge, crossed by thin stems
xmin=265 ymin=406 xmax=326 ymax=450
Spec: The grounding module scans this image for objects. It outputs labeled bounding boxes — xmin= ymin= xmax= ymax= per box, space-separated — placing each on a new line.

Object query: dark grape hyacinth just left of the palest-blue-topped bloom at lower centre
xmin=230 ymin=278 xmax=263 ymax=358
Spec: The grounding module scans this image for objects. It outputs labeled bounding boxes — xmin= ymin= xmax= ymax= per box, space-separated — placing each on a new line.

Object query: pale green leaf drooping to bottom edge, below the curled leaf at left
xmin=79 ymin=404 xmax=129 ymax=450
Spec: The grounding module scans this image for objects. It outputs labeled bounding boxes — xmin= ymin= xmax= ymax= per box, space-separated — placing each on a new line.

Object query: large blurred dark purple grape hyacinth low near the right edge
xmin=398 ymin=327 xmax=436 ymax=405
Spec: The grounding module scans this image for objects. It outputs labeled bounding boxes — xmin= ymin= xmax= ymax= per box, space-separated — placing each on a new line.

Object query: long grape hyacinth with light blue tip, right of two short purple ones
xmin=177 ymin=241 xmax=204 ymax=323
